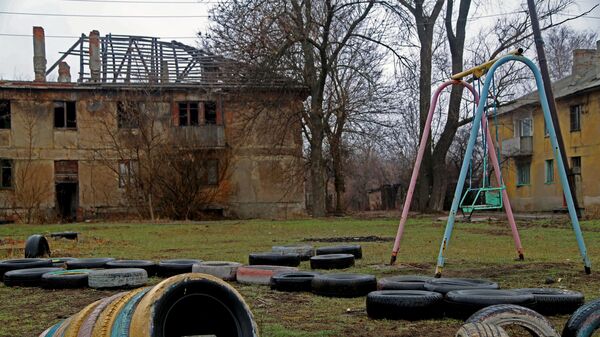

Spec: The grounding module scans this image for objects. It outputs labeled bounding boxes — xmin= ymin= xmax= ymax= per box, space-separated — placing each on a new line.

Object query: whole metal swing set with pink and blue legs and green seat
xmin=390 ymin=49 xmax=591 ymax=277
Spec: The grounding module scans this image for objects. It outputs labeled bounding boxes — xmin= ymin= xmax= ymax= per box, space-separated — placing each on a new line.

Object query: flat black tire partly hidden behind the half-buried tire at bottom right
xmin=444 ymin=289 xmax=534 ymax=319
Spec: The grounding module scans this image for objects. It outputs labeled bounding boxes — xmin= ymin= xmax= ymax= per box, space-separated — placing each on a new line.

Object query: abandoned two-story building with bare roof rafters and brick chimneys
xmin=0 ymin=27 xmax=306 ymax=221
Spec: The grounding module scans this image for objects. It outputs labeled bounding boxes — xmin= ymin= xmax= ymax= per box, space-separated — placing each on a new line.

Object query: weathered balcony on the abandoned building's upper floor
xmin=170 ymin=124 xmax=225 ymax=148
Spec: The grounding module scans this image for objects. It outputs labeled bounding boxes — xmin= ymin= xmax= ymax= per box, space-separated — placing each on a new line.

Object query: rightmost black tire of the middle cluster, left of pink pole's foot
xmin=311 ymin=274 xmax=377 ymax=297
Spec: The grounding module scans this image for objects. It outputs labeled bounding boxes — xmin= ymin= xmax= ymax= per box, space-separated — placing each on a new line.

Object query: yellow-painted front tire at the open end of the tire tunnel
xmin=129 ymin=273 xmax=258 ymax=337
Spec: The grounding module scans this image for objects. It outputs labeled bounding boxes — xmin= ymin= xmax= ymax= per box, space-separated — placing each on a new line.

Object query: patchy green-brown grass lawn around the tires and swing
xmin=0 ymin=217 xmax=600 ymax=337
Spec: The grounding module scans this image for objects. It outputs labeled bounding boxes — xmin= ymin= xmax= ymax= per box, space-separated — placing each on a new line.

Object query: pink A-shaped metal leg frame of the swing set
xmin=390 ymin=80 xmax=524 ymax=265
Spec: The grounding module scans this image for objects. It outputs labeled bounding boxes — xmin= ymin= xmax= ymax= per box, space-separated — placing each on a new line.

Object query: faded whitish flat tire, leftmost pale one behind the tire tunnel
xmin=88 ymin=268 xmax=148 ymax=288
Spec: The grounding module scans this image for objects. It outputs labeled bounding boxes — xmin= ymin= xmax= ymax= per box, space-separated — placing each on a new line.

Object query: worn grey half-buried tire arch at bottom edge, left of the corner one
xmin=467 ymin=304 xmax=559 ymax=337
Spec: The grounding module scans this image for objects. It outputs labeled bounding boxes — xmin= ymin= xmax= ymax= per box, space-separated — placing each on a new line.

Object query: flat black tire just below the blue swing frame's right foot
xmin=514 ymin=288 xmax=585 ymax=315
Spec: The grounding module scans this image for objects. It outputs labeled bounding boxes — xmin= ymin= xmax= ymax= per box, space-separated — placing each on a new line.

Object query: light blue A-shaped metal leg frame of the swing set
xmin=435 ymin=55 xmax=591 ymax=277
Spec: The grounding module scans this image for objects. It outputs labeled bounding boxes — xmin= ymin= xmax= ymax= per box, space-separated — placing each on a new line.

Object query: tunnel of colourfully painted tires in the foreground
xmin=39 ymin=273 xmax=258 ymax=337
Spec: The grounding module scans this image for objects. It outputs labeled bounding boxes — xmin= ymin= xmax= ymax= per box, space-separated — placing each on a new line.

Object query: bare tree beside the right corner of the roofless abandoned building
xmin=212 ymin=0 xmax=375 ymax=216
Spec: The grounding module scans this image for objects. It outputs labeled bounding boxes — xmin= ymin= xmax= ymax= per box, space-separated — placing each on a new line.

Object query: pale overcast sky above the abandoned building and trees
xmin=0 ymin=0 xmax=600 ymax=80
